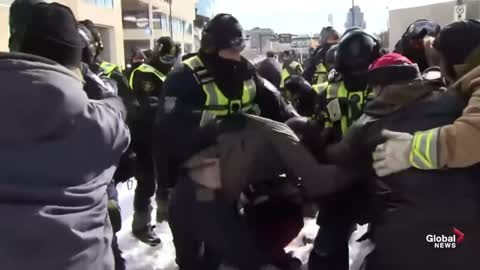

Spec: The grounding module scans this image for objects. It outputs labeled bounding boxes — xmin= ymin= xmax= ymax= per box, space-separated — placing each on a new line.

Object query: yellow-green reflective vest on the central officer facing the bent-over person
xmin=183 ymin=56 xmax=257 ymax=126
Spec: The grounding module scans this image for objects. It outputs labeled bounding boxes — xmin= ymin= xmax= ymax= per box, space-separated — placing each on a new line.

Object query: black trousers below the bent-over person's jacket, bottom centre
xmin=169 ymin=176 xmax=263 ymax=270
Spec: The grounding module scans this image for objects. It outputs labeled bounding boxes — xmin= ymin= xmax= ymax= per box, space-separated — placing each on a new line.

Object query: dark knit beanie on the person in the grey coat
xmin=20 ymin=3 xmax=85 ymax=67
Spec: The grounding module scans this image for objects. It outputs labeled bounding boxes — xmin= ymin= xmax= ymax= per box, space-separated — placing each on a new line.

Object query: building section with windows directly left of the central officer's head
xmin=122 ymin=0 xmax=196 ymax=58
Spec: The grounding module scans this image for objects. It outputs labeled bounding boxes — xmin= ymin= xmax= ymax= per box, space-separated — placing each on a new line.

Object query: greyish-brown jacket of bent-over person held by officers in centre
xmin=184 ymin=115 xmax=351 ymax=200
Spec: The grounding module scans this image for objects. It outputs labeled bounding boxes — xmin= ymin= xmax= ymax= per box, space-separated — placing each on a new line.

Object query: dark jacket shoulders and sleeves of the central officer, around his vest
xmin=153 ymin=53 xmax=298 ymax=187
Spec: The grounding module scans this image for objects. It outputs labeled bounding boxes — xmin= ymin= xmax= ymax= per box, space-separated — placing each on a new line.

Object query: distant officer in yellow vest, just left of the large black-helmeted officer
xmin=303 ymin=26 xmax=340 ymax=85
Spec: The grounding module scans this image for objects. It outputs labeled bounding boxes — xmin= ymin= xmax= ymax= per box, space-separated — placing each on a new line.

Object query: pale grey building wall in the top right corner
xmin=389 ymin=0 xmax=480 ymax=50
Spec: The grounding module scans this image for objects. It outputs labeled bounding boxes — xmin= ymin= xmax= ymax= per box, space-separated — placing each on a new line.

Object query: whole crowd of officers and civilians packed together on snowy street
xmin=0 ymin=0 xmax=480 ymax=270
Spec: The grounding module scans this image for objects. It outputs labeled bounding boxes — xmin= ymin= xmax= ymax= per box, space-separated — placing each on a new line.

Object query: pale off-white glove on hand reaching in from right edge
xmin=373 ymin=130 xmax=413 ymax=177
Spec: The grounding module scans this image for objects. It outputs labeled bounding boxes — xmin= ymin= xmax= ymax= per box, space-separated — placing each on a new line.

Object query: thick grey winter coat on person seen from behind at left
xmin=0 ymin=53 xmax=129 ymax=270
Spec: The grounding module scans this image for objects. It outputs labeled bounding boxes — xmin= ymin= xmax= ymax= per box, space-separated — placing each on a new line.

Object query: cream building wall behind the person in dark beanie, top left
xmin=0 ymin=0 xmax=125 ymax=67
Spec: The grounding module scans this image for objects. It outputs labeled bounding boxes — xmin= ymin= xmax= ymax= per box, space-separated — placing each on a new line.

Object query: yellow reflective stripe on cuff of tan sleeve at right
xmin=409 ymin=128 xmax=440 ymax=170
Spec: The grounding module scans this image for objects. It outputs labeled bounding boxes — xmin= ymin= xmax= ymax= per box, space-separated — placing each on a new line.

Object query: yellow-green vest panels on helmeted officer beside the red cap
xmin=325 ymin=82 xmax=367 ymax=135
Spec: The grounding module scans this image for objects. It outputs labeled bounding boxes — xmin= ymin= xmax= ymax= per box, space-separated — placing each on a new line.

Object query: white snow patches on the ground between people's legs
xmin=117 ymin=180 xmax=372 ymax=270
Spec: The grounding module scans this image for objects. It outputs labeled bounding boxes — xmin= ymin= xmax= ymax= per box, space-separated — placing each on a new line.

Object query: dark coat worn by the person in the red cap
xmin=328 ymin=80 xmax=480 ymax=270
